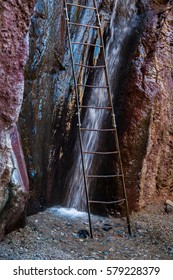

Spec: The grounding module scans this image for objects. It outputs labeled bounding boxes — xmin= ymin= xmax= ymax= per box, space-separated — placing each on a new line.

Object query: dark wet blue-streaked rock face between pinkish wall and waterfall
xmin=19 ymin=0 xmax=110 ymax=213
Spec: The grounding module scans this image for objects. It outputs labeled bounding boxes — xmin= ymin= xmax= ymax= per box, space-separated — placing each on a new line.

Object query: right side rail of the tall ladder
xmin=93 ymin=0 xmax=131 ymax=235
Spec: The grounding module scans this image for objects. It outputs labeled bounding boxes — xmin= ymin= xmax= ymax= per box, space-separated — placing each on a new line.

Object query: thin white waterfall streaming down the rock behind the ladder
xmin=65 ymin=0 xmax=136 ymax=211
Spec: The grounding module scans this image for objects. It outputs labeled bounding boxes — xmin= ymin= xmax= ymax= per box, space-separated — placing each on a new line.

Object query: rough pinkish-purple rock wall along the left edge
xmin=0 ymin=0 xmax=34 ymax=239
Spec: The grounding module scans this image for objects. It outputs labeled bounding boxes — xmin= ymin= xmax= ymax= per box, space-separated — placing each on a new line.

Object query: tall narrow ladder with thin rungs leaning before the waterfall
xmin=64 ymin=0 xmax=131 ymax=238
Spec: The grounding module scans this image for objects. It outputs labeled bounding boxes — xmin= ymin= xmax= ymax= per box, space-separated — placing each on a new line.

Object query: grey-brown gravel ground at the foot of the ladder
xmin=0 ymin=203 xmax=173 ymax=260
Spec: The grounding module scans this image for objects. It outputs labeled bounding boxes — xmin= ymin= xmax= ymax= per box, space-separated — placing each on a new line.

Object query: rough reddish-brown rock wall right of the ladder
xmin=122 ymin=1 xmax=173 ymax=208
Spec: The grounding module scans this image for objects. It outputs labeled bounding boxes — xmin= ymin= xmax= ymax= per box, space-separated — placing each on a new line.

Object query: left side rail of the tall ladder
xmin=64 ymin=0 xmax=93 ymax=238
